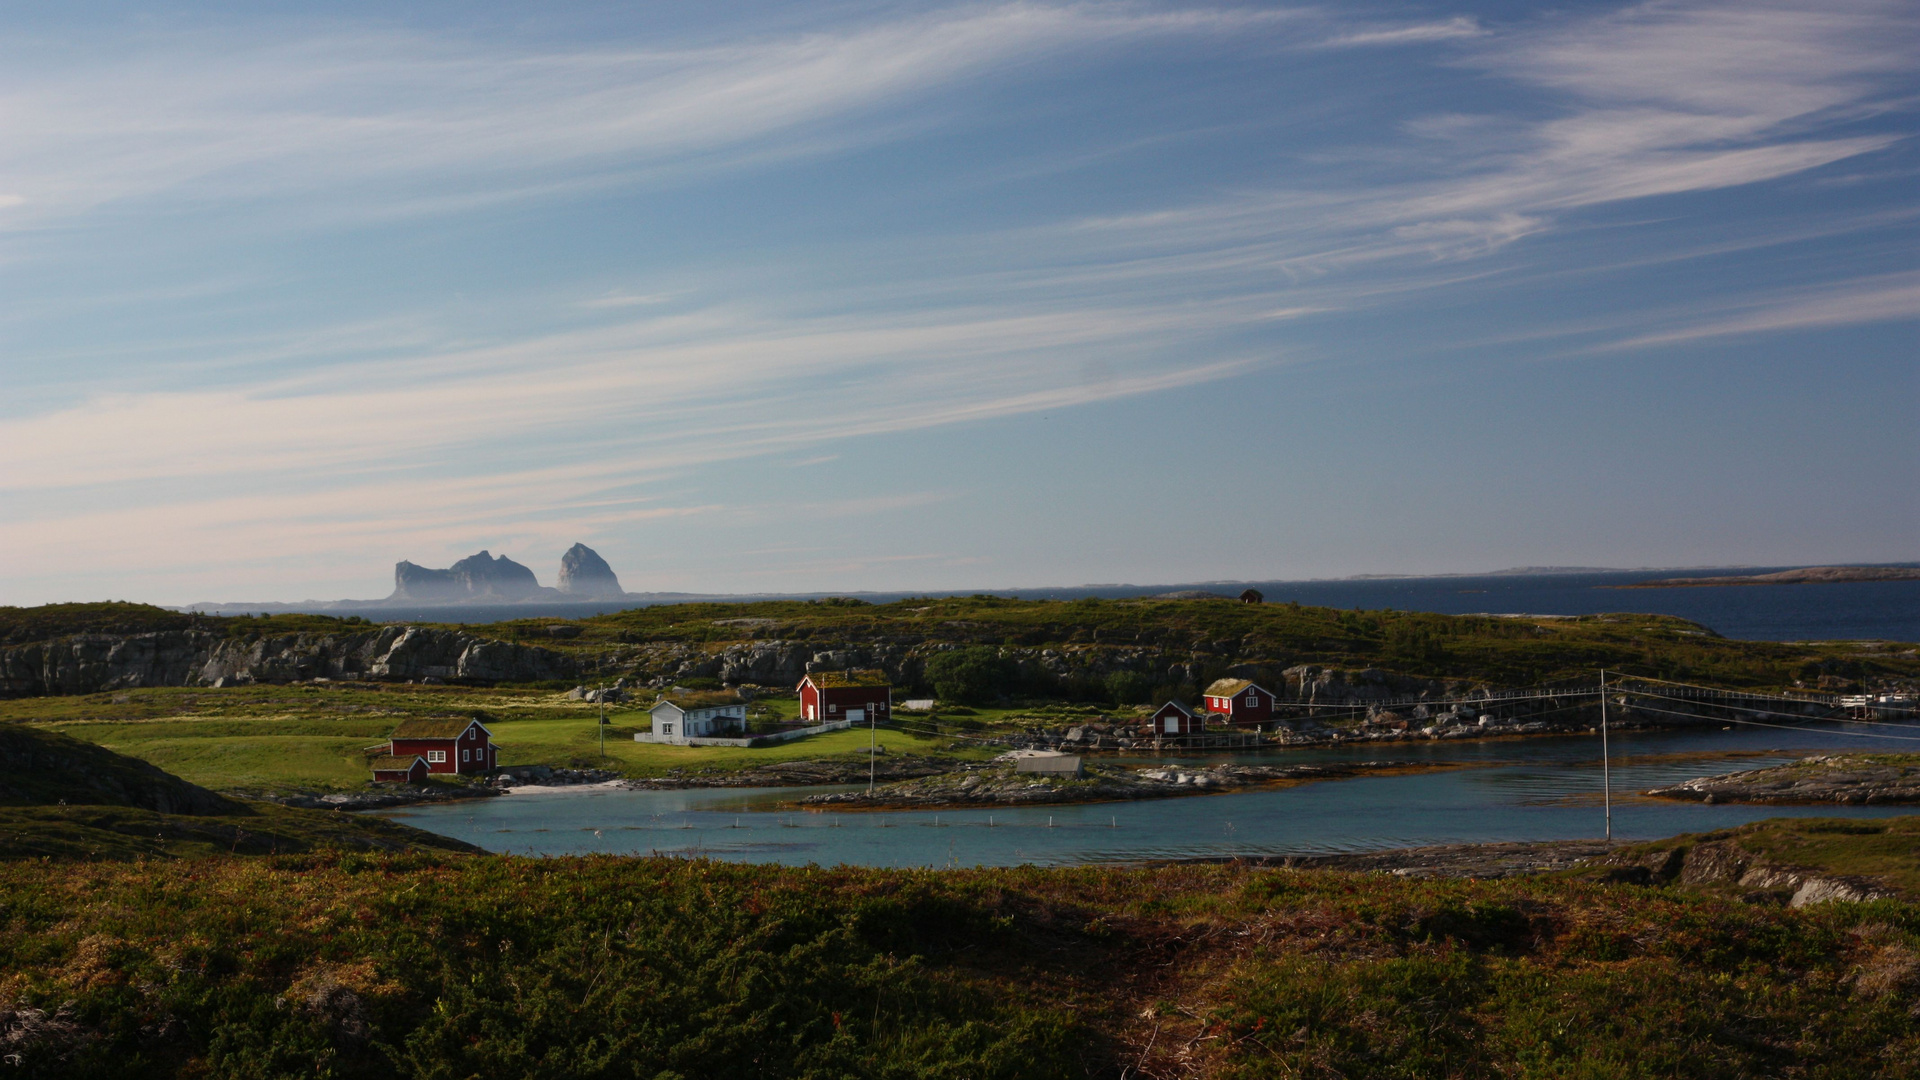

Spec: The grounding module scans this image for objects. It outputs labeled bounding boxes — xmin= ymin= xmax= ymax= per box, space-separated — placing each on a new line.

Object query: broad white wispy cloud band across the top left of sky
xmin=0 ymin=4 xmax=1292 ymax=227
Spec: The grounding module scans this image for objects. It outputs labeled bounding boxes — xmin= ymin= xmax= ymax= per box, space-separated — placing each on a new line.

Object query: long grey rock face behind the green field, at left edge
xmin=0 ymin=626 xmax=580 ymax=698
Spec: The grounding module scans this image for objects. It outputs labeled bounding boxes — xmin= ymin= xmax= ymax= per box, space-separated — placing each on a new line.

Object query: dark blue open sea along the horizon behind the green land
xmin=307 ymin=567 xmax=1920 ymax=642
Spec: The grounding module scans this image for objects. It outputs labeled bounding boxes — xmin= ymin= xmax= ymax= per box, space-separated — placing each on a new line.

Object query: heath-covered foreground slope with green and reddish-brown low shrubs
xmin=0 ymin=855 xmax=1920 ymax=1078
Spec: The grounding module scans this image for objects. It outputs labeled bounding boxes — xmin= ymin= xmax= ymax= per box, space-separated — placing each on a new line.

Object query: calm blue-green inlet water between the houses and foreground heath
xmin=388 ymin=728 xmax=1920 ymax=867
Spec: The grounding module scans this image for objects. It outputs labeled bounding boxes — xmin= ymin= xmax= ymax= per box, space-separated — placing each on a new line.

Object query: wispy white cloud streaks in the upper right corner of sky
xmin=1075 ymin=0 xmax=1920 ymax=288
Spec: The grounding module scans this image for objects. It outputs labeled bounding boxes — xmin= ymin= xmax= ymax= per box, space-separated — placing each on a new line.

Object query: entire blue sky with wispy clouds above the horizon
xmin=0 ymin=0 xmax=1920 ymax=603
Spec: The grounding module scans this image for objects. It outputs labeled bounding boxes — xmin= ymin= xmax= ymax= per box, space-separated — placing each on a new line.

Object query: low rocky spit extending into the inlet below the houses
xmin=799 ymin=761 xmax=1452 ymax=809
